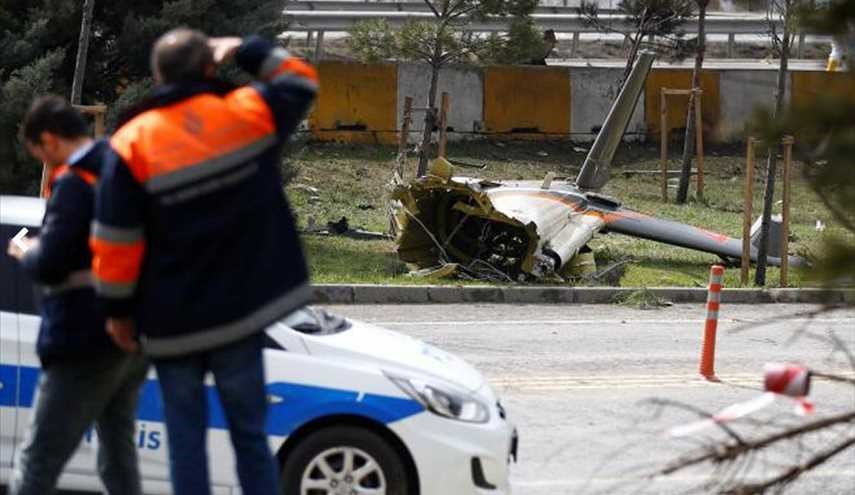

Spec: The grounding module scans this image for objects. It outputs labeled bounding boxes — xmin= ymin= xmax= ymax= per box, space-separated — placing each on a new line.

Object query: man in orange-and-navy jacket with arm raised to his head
xmin=92 ymin=29 xmax=317 ymax=495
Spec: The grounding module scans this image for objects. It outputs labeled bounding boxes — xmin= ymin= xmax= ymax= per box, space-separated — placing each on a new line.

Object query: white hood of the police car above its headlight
xmin=302 ymin=320 xmax=485 ymax=392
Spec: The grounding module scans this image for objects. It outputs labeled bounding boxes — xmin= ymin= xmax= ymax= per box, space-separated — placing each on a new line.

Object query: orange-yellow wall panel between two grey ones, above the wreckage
xmin=484 ymin=67 xmax=570 ymax=137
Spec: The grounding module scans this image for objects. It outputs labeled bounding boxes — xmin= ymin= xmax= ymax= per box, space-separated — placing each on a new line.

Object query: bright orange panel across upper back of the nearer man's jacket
xmin=110 ymin=87 xmax=275 ymax=183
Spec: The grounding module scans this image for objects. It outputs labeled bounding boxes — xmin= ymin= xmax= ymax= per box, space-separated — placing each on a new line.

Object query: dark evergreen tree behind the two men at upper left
xmin=0 ymin=0 xmax=287 ymax=195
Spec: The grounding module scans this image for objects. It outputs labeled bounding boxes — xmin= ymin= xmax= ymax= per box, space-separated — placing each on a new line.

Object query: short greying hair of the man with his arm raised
xmin=151 ymin=28 xmax=214 ymax=84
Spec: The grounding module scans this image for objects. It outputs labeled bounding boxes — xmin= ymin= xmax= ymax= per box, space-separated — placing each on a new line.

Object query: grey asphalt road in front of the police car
xmin=322 ymin=305 xmax=855 ymax=495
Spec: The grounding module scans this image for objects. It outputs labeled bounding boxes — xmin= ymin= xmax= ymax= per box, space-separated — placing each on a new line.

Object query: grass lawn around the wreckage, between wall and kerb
xmin=288 ymin=141 xmax=844 ymax=287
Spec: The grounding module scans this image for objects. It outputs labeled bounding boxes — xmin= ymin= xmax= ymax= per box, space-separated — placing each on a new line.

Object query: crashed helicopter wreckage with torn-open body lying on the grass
xmin=392 ymin=53 xmax=805 ymax=281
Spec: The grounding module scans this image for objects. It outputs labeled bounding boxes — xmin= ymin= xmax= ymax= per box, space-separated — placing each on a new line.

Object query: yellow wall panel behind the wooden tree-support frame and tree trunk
xmin=644 ymin=69 xmax=721 ymax=140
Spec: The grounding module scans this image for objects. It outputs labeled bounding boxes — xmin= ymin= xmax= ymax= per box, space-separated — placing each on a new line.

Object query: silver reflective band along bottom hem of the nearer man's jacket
xmin=141 ymin=284 xmax=312 ymax=358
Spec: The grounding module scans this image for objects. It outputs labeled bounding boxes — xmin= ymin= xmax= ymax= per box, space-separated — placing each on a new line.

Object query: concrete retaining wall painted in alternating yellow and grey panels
xmin=309 ymin=61 xmax=844 ymax=144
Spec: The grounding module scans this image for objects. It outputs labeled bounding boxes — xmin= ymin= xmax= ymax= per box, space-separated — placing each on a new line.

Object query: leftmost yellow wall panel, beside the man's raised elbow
xmin=309 ymin=61 xmax=398 ymax=143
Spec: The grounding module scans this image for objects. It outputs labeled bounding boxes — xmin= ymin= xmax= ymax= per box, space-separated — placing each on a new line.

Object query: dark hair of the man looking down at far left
xmin=22 ymin=96 xmax=89 ymax=144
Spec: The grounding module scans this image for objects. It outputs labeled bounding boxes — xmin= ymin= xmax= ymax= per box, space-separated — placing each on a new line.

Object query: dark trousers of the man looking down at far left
xmin=9 ymin=351 xmax=148 ymax=495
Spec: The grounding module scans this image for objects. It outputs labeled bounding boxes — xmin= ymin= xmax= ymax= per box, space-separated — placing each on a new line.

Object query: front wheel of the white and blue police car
xmin=282 ymin=426 xmax=408 ymax=495
